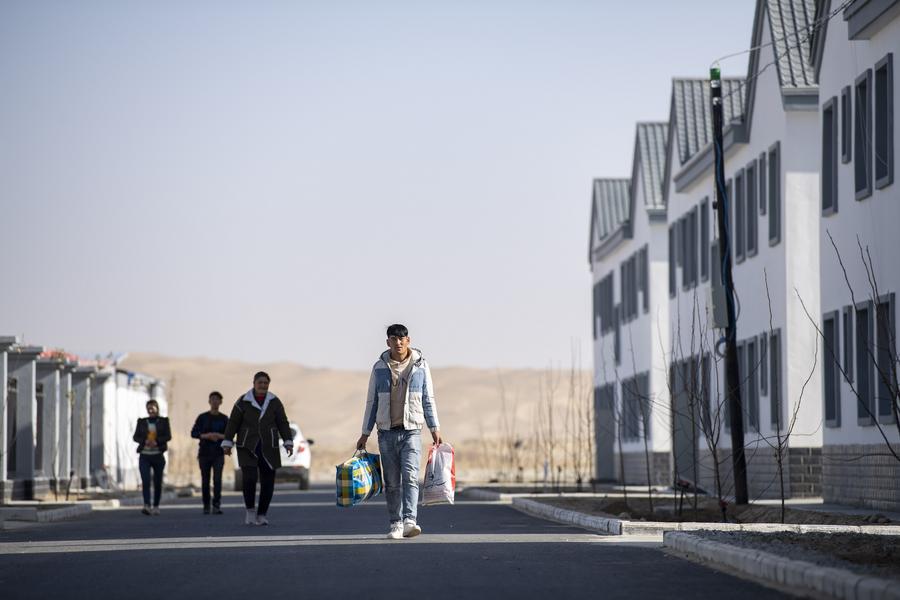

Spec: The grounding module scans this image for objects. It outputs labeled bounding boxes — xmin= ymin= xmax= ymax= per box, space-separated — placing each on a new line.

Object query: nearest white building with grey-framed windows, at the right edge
xmin=814 ymin=0 xmax=900 ymax=510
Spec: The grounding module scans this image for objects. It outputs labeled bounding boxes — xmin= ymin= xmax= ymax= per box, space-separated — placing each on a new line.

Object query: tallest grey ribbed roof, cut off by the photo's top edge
xmin=763 ymin=0 xmax=816 ymax=88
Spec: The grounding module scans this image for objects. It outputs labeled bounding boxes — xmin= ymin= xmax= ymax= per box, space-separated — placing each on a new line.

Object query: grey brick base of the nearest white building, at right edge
xmin=822 ymin=444 xmax=900 ymax=511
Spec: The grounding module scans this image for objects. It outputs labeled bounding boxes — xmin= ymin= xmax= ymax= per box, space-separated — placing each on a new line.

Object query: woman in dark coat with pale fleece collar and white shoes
xmin=222 ymin=371 xmax=294 ymax=525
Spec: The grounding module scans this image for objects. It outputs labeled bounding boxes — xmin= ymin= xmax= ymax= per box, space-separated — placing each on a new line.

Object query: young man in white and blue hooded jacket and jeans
xmin=356 ymin=324 xmax=441 ymax=540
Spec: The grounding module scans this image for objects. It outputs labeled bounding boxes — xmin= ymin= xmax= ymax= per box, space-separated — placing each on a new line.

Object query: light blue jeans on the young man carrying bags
xmin=378 ymin=428 xmax=422 ymax=523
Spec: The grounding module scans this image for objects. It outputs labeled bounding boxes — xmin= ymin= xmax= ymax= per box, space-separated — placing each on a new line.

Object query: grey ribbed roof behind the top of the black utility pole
xmin=672 ymin=78 xmax=746 ymax=164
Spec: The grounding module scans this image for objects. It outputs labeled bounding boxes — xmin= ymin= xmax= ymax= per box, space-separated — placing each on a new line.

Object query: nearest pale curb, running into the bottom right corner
xmin=663 ymin=531 xmax=900 ymax=600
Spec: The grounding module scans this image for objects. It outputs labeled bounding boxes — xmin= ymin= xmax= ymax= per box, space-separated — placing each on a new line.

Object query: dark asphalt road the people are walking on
xmin=0 ymin=489 xmax=784 ymax=600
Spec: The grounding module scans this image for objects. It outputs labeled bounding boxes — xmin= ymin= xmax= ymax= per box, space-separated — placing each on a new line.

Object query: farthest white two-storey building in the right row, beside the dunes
xmin=589 ymin=123 xmax=672 ymax=485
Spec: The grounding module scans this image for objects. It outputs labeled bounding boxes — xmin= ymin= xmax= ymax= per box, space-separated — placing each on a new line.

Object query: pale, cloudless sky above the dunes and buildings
xmin=0 ymin=0 xmax=754 ymax=369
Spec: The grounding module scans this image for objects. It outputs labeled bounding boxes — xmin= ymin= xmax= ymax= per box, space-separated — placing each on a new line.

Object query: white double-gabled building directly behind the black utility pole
xmin=667 ymin=0 xmax=822 ymax=499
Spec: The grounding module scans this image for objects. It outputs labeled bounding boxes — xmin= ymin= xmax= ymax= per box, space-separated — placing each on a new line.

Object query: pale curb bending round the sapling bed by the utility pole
xmin=511 ymin=498 xmax=900 ymax=539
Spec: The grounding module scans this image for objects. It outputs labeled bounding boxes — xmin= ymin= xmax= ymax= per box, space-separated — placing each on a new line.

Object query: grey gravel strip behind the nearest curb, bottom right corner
xmin=692 ymin=531 xmax=900 ymax=580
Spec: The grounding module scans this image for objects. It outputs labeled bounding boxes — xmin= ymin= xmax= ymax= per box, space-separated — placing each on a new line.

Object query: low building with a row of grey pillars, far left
xmin=0 ymin=336 xmax=168 ymax=503
